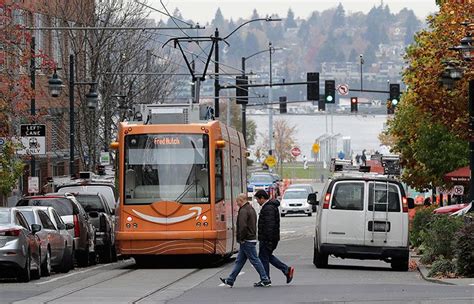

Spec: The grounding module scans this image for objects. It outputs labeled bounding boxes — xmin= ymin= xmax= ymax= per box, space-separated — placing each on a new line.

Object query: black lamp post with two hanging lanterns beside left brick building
xmin=48 ymin=54 xmax=99 ymax=176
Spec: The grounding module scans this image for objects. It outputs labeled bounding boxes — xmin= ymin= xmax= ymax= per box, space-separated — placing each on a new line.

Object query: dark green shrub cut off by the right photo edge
xmin=454 ymin=222 xmax=474 ymax=278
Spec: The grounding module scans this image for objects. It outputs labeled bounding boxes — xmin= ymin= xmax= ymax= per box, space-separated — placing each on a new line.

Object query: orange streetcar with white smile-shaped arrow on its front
xmin=112 ymin=105 xmax=247 ymax=261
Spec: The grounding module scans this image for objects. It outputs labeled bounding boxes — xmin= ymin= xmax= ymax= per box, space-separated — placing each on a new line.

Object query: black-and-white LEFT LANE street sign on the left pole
xmin=17 ymin=125 xmax=46 ymax=155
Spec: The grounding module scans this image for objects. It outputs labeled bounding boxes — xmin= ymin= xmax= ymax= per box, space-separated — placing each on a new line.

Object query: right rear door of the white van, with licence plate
xmin=364 ymin=181 xmax=402 ymax=247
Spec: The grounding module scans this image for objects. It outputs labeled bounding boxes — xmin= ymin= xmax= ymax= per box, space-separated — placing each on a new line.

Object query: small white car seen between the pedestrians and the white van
xmin=280 ymin=188 xmax=313 ymax=217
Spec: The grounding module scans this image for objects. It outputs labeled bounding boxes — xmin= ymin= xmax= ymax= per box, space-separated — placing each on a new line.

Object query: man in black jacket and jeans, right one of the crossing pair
xmin=255 ymin=190 xmax=295 ymax=283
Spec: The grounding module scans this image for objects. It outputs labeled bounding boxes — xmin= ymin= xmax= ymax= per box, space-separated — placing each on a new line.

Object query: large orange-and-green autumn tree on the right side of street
xmin=388 ymin=3 xmax=474 ymax=189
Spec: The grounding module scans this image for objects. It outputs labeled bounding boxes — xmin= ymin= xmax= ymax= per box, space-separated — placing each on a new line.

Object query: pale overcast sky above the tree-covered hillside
xmin=148 ymin=0 xmax=438 ymax=24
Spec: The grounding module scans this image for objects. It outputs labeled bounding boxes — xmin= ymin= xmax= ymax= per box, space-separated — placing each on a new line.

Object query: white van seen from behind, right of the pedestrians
xmin=309 ymin=173 xmax=414 ymax=271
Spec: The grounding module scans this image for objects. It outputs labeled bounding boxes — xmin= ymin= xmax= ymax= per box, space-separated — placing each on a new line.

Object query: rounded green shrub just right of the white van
xmin=422 ymin=214 xmax=463 ymax=259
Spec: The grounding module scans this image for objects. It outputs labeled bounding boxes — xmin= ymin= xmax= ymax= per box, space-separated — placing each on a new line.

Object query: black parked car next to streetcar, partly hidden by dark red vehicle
xmin=74 ymin=192 xmax=117 ymax=263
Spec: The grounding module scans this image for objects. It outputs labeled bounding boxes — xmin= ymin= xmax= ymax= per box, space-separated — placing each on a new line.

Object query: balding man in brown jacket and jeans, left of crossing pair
xmin=220 ymin=193 xmax=271 ymax=287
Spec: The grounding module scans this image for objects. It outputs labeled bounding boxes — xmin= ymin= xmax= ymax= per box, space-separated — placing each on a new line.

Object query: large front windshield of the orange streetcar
xmin=124 ymin=134 xmax=210 ymax=204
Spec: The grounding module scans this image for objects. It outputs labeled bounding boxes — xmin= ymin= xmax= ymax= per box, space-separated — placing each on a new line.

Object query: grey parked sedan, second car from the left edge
xmin=15 ymin=206 xmax=73 ymax=277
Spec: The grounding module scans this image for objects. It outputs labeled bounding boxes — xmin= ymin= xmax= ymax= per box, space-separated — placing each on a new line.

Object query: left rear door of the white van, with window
xmin=322 ymin=181 xmax=365 ymax=245
